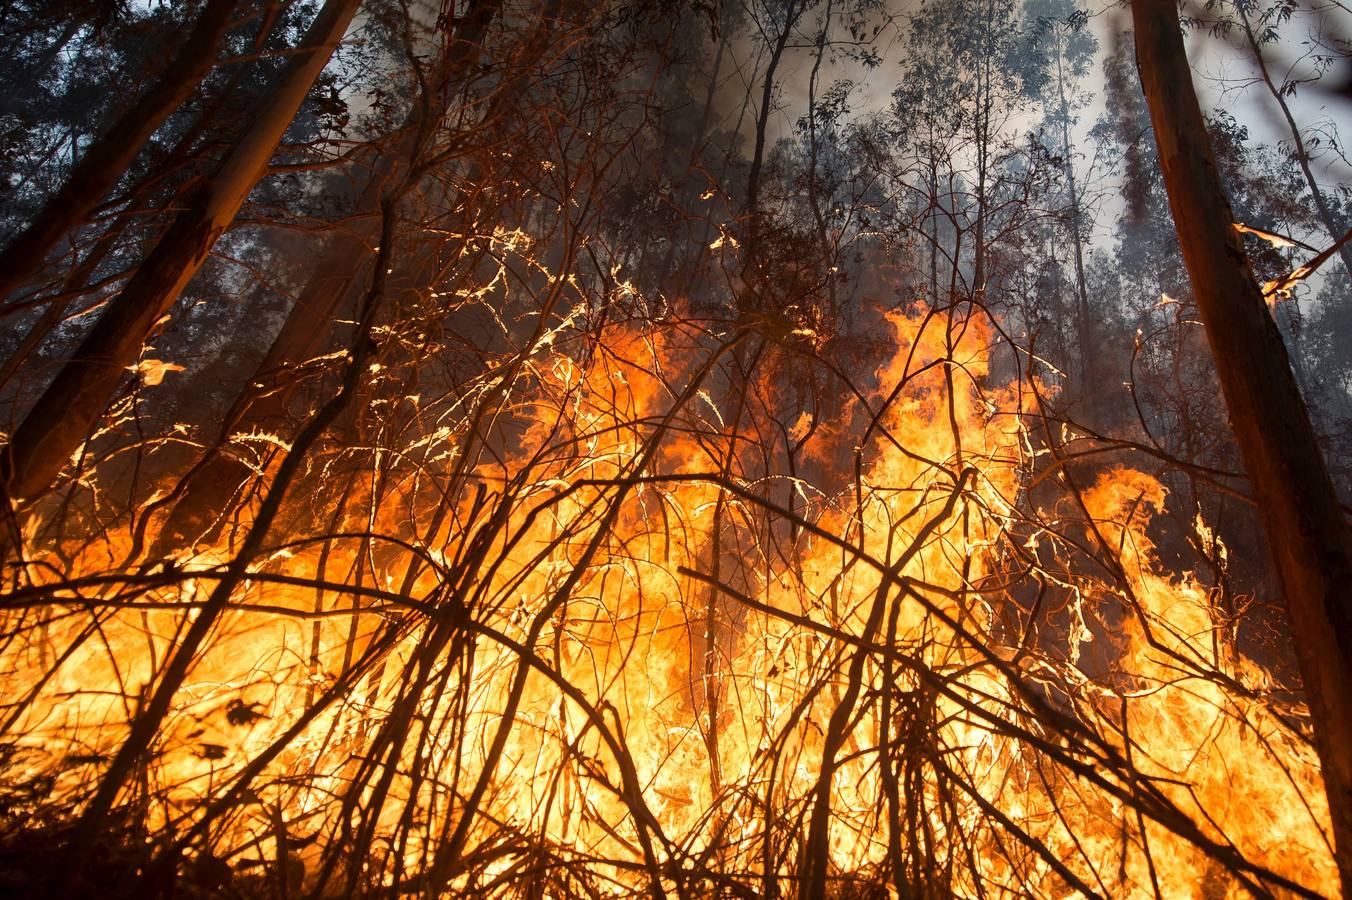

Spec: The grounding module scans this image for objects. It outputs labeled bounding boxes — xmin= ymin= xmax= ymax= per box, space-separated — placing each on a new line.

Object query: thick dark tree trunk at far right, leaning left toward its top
xmin=1132 ymin=0 xmax=1352 ymax=896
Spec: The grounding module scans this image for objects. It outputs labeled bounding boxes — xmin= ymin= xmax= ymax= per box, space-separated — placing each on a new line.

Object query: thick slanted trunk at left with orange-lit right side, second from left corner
xmin=0 ymin=0 xmax=361 ymax=503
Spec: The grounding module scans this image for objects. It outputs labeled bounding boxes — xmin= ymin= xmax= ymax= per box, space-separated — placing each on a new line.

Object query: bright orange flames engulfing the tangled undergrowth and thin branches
xmin=3 ymin=304 xmax=1336 ymax=897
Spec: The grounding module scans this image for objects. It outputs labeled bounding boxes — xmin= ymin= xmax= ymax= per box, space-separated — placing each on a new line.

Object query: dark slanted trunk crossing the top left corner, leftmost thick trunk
xmin=0 ymin=0 xmax=239 ymax=297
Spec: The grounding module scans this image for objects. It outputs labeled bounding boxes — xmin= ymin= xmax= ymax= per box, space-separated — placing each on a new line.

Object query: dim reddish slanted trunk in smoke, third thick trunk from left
xmin=151 ymin=0 xmax=508 ymax=557
